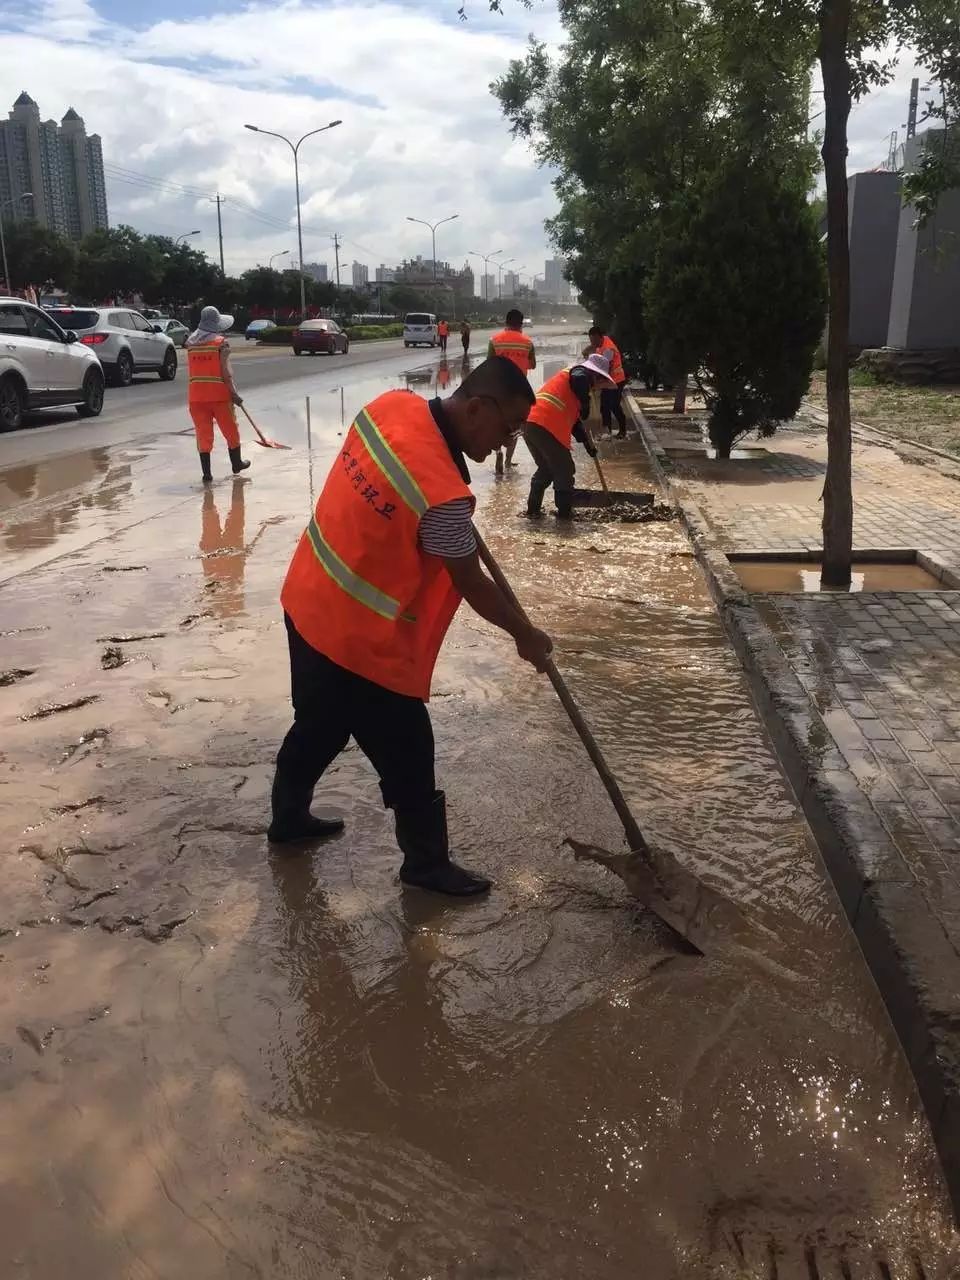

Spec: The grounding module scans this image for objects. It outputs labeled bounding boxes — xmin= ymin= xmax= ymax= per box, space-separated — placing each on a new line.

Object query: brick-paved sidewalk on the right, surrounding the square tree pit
xmin=634 ymin=397 xmax=960 ymax=1208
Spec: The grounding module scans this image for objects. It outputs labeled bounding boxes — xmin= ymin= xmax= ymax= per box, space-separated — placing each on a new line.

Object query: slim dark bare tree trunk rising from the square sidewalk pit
xmin=819 ymin=0 xmax=854 ymax=586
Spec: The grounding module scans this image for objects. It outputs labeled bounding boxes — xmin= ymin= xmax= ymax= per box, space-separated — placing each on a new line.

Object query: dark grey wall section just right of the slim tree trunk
xmin=847 ymin=173 xmax=900 ymax=347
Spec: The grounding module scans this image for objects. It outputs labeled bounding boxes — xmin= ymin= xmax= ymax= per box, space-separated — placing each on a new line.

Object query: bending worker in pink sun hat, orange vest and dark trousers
xmin=524 ymin=352 xmax=613 ymax=520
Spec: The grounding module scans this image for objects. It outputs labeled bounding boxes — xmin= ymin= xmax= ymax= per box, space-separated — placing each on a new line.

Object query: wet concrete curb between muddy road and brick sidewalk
xmin=626 ymin=394 xmax=960 ymax=1221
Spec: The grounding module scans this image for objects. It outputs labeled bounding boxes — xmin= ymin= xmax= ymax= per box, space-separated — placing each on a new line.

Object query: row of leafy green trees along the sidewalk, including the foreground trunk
xmin=492 ymin=0 xmax=960 ymax=586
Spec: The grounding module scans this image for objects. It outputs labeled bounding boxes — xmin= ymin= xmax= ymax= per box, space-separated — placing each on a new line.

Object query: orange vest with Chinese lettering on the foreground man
xmin=280 ymin=392 xmax=474 ymax=701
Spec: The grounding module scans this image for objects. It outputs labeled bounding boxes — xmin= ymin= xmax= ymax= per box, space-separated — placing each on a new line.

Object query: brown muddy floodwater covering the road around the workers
xmin=0 ymin=352 xmax=960 ymax=1280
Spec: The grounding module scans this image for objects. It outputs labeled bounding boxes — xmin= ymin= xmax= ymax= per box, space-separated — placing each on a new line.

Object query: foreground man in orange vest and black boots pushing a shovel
xmin=268 ymin=360 xmax=553 ymax=897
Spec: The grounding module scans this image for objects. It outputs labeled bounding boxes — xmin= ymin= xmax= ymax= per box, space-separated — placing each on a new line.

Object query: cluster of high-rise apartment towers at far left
xmin=0 ymin=90 xmax=109 ymax=239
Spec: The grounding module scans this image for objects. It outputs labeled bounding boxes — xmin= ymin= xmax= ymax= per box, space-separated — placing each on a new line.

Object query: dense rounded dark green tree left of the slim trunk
xmin=646 ymin=157 xmax=826 ymax=457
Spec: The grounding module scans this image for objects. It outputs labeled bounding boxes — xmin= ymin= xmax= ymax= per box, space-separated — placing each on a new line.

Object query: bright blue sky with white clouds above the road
xmin=0 ymin=0 xmax=942 ymax=276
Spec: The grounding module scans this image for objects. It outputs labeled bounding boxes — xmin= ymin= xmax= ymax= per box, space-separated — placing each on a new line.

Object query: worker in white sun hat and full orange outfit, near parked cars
xmin=183 ymin=307 xmax=250 ymax=484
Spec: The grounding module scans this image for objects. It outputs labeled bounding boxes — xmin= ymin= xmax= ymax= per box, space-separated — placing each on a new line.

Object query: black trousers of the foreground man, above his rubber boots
xmin=276 ymin=614 xmax=436 ymax=809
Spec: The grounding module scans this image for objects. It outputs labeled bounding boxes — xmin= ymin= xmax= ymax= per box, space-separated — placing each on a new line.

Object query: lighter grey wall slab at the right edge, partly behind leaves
xmin=886 ymin=129 xmax=960 ymax=351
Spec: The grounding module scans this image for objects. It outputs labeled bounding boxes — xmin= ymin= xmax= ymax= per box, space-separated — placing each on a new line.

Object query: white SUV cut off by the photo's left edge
xmin=0 ymin=298 xmax=104 ymax=431
